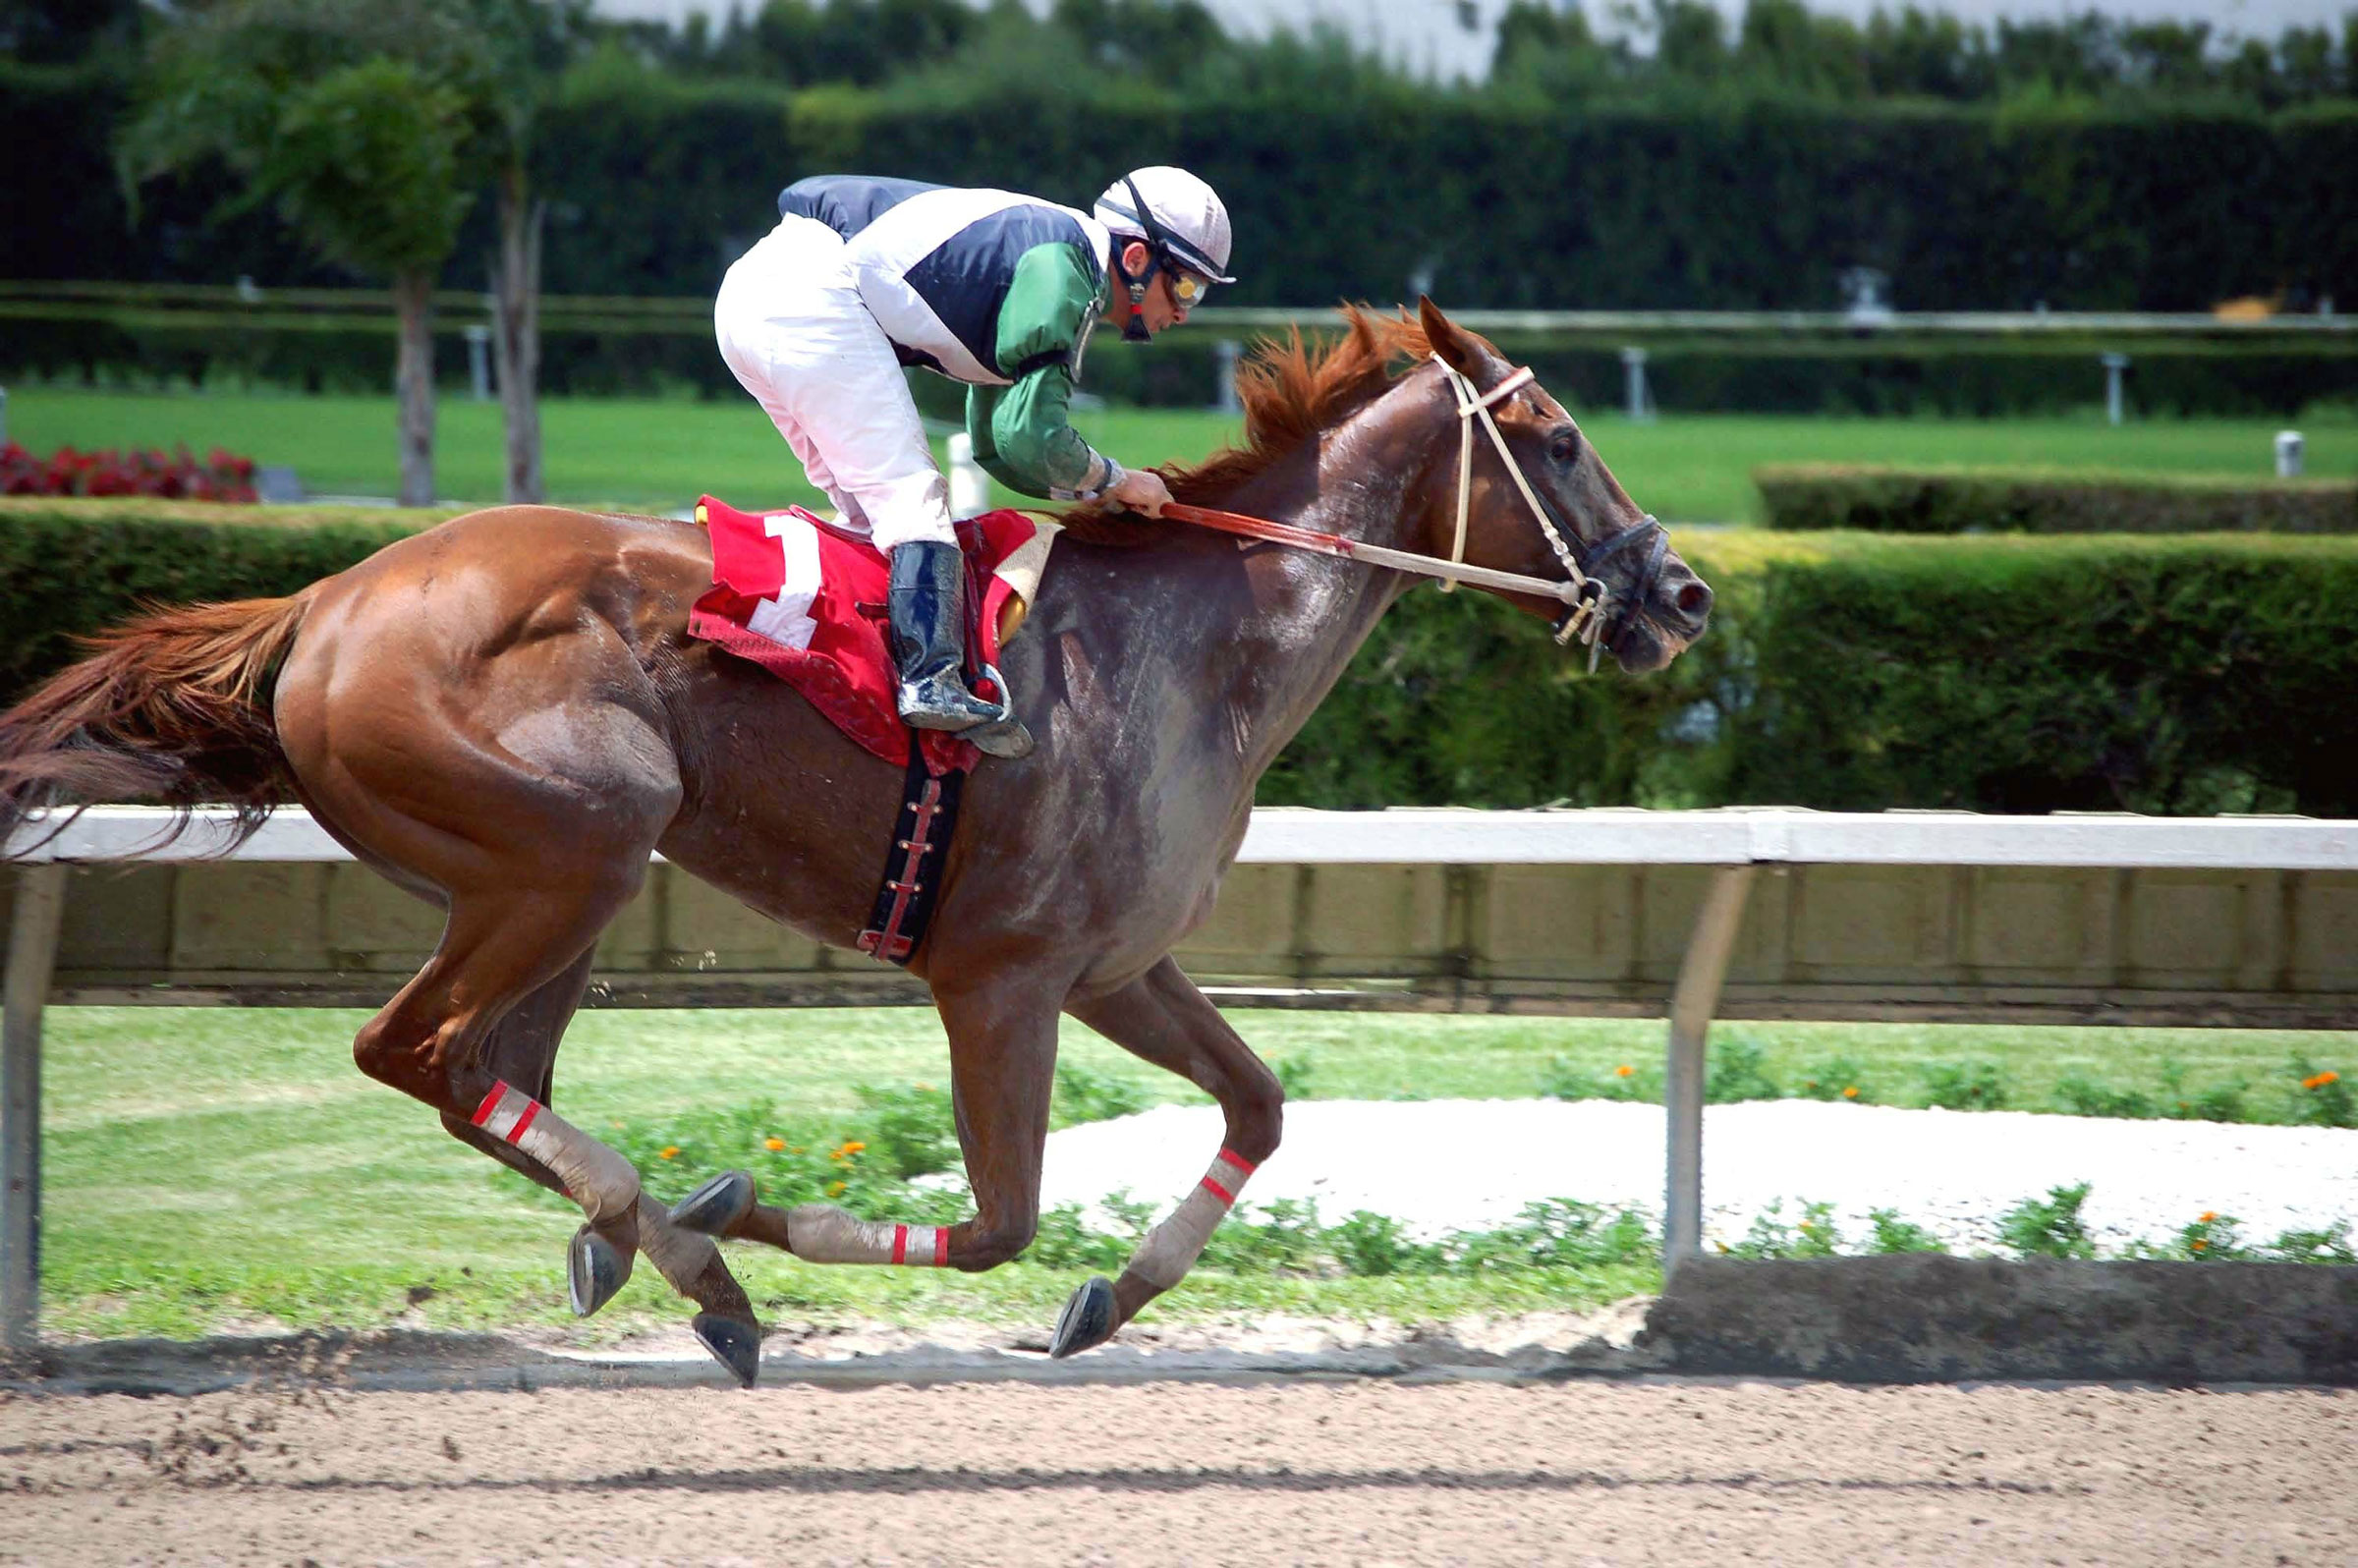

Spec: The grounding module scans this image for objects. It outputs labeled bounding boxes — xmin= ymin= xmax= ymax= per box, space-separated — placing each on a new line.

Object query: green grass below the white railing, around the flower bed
xmin=42 ymin=1007 xmax=2358 ymax=1337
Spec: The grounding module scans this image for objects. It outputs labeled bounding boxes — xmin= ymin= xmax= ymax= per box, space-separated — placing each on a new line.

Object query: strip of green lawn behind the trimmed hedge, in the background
xmin=7 ymin=387 xmax=2358 ymax=521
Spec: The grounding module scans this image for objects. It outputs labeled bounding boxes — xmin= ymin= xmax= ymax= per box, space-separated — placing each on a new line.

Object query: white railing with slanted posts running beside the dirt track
xmin=0 ymin=807 xmax=2358 ymax=1344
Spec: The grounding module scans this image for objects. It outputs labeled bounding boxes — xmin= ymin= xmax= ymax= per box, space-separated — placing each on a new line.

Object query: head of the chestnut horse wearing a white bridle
xmin=1417 ymin=300 xmax=1712 ymax=674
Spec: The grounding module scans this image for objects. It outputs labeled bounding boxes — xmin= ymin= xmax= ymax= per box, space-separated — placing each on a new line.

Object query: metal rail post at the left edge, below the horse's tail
xmin=0 ymin=861 xmax=66 ymax=1351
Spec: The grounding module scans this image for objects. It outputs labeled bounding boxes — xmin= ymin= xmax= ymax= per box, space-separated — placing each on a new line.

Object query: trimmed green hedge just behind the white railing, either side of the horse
xmin=0 ymin=502 xmax=2358 ymax=815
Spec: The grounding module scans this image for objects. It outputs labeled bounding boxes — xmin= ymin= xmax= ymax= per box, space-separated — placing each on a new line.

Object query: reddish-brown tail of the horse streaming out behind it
xmin=0 ymin=594 xmax=311 ymax=847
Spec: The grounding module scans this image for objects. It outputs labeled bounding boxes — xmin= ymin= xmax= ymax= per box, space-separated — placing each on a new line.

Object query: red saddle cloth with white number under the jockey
xmin=689 ymin=495 xmax=1059 ymax=776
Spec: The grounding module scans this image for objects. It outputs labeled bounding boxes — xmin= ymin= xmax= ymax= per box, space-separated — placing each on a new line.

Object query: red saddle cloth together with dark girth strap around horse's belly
xmin=689 ymin=495 xmax=1061 ymax=965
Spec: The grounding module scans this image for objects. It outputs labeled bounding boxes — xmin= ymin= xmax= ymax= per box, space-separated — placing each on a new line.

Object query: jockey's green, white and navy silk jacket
xmin=778 ymin=175 xmax=1120 ymax=497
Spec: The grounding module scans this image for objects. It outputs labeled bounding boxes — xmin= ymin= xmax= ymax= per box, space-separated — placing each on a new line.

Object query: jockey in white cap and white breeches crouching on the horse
xmin=712 ymin=165 xmax=1233 ymax=756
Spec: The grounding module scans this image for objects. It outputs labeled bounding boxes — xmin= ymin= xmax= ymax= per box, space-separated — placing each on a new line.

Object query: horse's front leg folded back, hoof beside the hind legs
xmin=672 ymin=977 xmax=1063 ymax=1271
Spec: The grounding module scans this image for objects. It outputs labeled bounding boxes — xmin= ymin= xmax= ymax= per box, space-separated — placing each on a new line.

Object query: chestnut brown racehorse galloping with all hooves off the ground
xmin=0 ymin=302 xmax=1712 ymax=1381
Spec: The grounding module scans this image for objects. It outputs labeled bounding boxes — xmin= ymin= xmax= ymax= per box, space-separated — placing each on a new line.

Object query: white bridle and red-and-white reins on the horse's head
xmin=1162 ymin=354 xmax=1669 ymax=672
